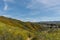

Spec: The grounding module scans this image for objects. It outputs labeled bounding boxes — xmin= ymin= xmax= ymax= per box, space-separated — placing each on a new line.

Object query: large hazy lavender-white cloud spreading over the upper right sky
xmin=27 ymin=0 xmax=60 ymax=15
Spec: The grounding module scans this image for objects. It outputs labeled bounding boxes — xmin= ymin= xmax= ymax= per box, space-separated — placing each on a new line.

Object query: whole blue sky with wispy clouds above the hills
xmin=0 ymin=0 xmax=60 ymax=22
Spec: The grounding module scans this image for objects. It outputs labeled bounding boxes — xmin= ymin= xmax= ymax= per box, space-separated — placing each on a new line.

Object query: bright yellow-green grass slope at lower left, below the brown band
xmin=0 ymin=22 xmax=34 ymax=40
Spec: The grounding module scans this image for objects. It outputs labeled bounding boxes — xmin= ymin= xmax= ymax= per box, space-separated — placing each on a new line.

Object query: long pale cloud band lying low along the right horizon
xmin=24 ymin=16 xmax=60 ymax=22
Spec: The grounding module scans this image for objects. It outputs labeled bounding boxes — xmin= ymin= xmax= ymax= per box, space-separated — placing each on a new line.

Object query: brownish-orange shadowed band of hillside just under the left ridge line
xmin=0 ymin=16 xmax=42 ymax=31
